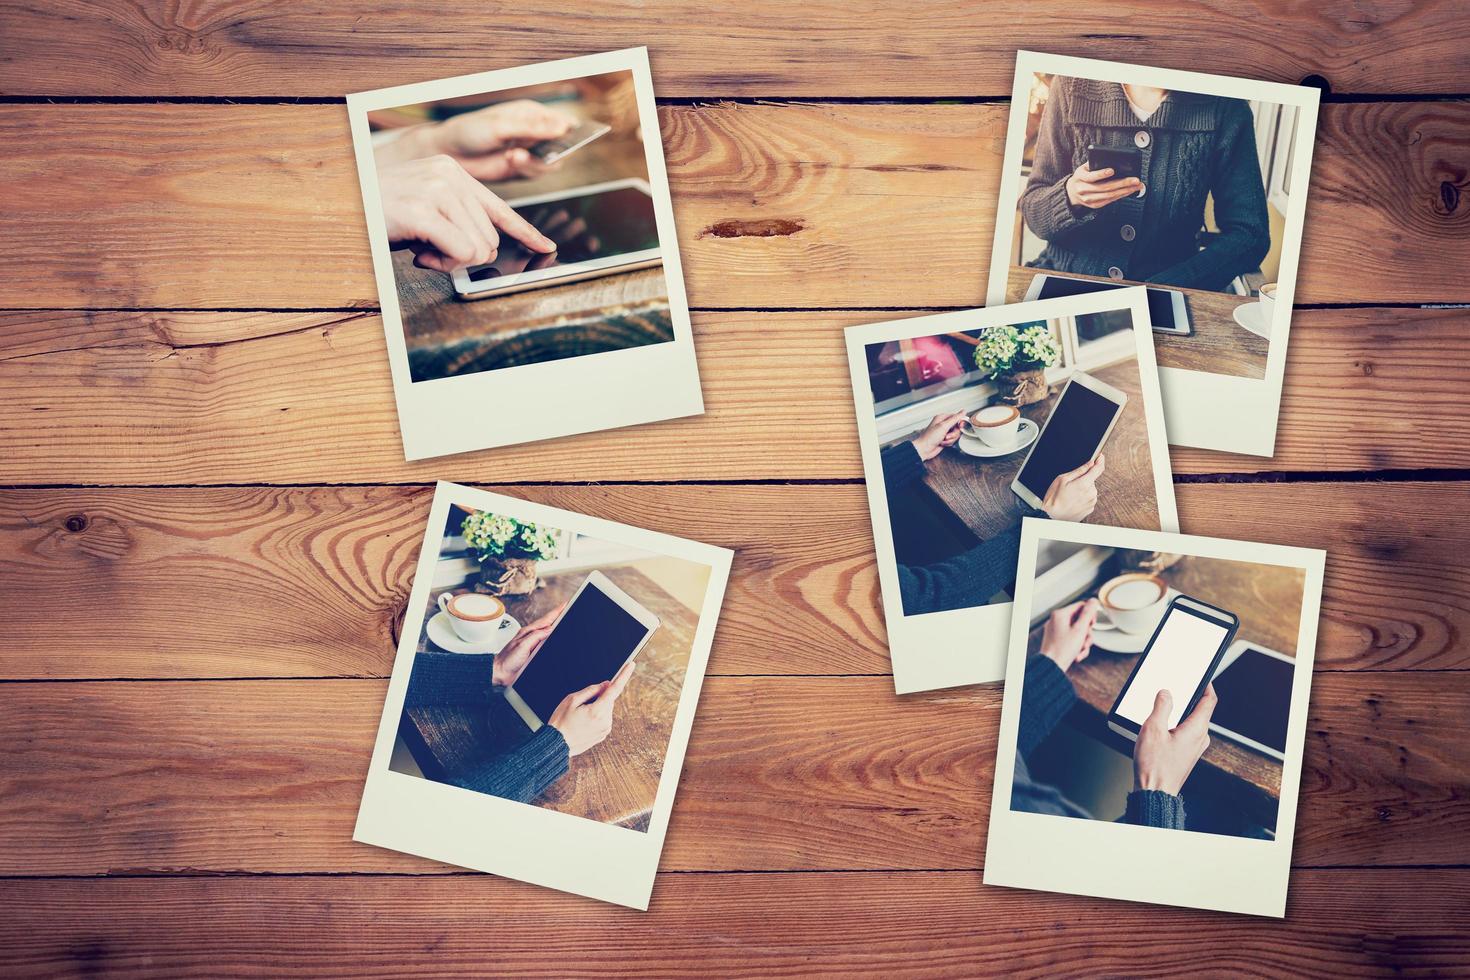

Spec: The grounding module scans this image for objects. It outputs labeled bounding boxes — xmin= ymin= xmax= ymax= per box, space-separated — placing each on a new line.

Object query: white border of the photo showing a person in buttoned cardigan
xmin=986 ymin=51 xmax=1320 ymax=457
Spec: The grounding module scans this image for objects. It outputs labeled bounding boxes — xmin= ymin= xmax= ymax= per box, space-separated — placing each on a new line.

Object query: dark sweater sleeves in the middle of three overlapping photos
xmin=882 ymin=442 xmax=1045 ymax=616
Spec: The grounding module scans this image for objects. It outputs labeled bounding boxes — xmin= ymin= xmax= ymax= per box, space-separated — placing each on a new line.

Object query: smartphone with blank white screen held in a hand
xmin=1107 ymin=595 xmax=1241 ymax=742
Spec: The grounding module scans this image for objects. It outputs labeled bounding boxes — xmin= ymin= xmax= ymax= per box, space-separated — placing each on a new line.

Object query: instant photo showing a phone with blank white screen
xmin=985 ymin=520 xmax=1324 ymax=917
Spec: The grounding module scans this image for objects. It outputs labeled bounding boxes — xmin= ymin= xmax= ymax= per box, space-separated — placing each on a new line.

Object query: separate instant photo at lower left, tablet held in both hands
xmin=353 ymin=483 xmax=731 ymax=908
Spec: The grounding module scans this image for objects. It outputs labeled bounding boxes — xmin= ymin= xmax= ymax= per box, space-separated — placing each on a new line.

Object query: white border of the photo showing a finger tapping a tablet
xmin=347 ymin=47 xmax=704 ymax=460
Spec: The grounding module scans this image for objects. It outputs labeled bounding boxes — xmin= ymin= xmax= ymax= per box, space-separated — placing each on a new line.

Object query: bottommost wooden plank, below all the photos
xmin=0 ymin=868 xmax=1470 ymax=977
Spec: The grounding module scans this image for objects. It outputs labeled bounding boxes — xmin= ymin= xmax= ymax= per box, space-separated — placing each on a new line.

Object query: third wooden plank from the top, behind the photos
xmin=0 ymin=309 xmax=1470 ymax=485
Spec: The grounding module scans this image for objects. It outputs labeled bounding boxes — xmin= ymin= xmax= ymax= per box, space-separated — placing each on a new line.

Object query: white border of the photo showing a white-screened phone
xmin=985 ymin=519 xmax=1326 ymax=918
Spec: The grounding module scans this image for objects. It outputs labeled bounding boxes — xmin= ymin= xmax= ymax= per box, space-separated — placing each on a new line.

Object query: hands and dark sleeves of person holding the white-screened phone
xmin=1011 ymin=599 xmax=1216 ymax=830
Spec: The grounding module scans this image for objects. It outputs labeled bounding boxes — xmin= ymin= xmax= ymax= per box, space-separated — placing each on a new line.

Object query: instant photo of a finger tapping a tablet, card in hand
xmin=347 ymin=48 xmax=704 ymax=460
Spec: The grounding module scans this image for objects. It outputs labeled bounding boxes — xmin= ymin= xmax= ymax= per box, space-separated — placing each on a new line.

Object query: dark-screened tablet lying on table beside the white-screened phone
xmin=1210 ymin=639 xmax=1297 ymax=763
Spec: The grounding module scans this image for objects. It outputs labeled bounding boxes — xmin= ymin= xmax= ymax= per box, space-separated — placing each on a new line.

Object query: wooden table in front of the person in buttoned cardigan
xmin=1005 ymin=266 xmax=1270 ymax=378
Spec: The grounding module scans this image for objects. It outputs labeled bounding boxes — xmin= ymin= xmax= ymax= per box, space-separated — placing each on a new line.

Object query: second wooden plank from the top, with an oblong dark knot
xmin=0 ymin=101 xmax=1470 ymax=309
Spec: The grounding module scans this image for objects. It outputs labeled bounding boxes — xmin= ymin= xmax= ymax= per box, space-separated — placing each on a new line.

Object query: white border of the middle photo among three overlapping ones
xmin=847 ymin=287 xmax=1179 ymax=693
